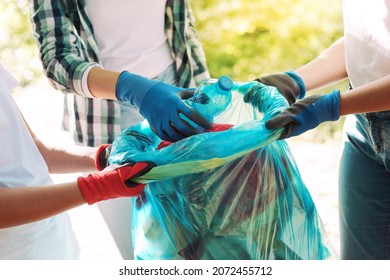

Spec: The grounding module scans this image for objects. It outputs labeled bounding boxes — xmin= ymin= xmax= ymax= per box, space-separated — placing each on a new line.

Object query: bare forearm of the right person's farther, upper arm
xmin=295 ymin=38 xmax=347 ymax=91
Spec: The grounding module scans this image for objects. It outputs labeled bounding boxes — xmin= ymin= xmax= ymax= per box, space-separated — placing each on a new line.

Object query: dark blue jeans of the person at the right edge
xmin=339 ymin=111 xmax=390 ymax=260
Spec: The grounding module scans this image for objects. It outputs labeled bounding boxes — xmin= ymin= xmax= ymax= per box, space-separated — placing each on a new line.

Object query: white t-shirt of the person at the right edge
xmin=343 ymin=0 xmax=390 ymax=87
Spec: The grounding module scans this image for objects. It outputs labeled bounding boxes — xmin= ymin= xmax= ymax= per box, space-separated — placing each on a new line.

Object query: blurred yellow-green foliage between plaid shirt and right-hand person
xmin=191 ymin=0 xmax=343 ymax=80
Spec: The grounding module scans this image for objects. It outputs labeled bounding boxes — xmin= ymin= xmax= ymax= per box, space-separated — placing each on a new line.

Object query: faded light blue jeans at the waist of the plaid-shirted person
xmin=120 ymin=64 xmax=177 ymax=130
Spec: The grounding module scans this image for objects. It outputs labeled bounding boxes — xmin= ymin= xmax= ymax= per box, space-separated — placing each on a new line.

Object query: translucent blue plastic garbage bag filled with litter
xmin=109 ymin=79 xmax=335 ymax=260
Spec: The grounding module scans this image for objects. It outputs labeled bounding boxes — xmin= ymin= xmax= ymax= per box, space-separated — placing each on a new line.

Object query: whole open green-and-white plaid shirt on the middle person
xmin=31 ymin=0 xmax=209 ymax=146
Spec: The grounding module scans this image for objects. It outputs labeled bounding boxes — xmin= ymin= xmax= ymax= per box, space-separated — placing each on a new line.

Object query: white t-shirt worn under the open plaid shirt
xmin=87 ymin=0 xmax=173 ymax=78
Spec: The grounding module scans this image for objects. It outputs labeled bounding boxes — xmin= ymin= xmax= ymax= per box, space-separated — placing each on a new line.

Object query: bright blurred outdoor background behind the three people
xmin=0 ymin=0 xmax=347 ymax=259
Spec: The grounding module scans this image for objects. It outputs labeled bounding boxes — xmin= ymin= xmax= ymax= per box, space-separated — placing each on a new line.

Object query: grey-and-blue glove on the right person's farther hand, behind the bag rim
xmin=255 ymin=71 xmax=306 ymax=105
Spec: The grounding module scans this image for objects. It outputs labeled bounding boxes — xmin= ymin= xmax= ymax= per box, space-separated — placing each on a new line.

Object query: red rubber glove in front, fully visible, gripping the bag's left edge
xmin=77 ymin=162 xmax=156 ymax=204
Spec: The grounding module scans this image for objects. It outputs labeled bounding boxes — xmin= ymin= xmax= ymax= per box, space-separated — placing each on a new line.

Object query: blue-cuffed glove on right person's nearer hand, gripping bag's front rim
xmin=265 ymin=90 xmax=340 ymax=139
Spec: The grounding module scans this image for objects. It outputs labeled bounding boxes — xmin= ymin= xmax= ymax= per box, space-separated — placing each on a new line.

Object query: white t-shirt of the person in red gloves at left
xmin=0 ymin=63 xmax=79 ymax=260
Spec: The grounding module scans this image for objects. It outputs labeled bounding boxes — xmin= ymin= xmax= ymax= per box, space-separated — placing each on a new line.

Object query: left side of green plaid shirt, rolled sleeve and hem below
xmin=30 ymin=0 xmax=121 ymax=147
